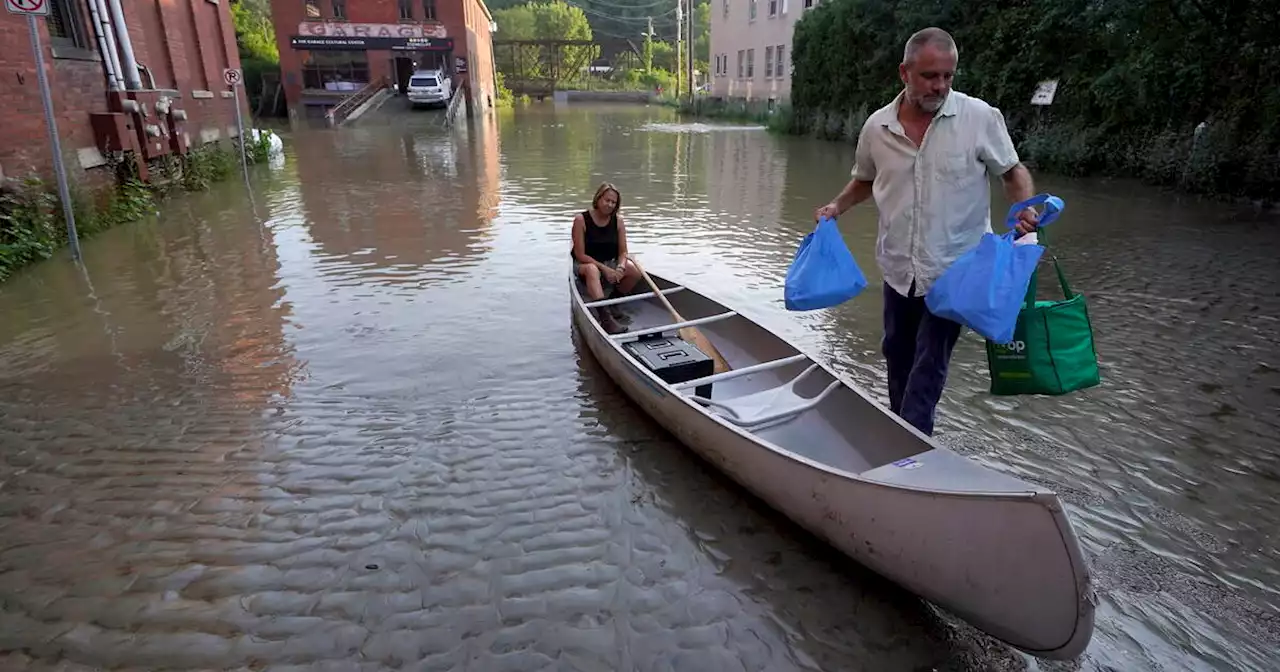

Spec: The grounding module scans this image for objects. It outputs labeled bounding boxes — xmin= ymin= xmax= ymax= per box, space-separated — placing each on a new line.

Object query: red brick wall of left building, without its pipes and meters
xmin=0 ymin=0 xmax=248 ymax=193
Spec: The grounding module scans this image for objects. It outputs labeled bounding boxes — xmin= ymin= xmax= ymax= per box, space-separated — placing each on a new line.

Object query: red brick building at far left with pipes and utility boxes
xmin=0 ymin=0 xmax=247 ymax=187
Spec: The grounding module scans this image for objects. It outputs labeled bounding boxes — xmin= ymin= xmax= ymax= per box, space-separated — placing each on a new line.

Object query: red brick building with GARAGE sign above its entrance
xmin=271 ymin=0 xmax=495 ymax=119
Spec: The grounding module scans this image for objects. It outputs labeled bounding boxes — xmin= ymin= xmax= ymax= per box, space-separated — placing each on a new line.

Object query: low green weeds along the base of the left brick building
xmin=0 ymin=133 xmax=270 ymax=282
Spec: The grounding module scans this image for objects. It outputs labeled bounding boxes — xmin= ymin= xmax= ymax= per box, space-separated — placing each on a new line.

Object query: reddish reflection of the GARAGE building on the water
xmin=294 ymin=115 xmax=499 ymax=284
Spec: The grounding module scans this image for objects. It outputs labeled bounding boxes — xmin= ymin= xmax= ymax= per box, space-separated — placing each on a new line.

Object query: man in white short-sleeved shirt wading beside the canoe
xmin=814 ymin=28 xmax=1038 ymax=435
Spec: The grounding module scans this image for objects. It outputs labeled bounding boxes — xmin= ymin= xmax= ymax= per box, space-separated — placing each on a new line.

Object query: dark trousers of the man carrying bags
xmin=883 ymin=283 xmax=961 ymax=436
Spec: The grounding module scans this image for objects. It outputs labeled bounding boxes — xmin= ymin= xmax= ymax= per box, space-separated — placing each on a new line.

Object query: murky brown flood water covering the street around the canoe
xmin=0 ymin=104 xmax=1280 ymax=672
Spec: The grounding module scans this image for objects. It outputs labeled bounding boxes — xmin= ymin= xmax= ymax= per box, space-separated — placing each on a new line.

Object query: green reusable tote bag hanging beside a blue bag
xmin=987 ymin=232 xmax=1101 ymax=396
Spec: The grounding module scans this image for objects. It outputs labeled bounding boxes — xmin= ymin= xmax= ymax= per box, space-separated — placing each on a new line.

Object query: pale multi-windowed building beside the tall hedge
xmin=710 ymin=0 xmax=818 ymax=101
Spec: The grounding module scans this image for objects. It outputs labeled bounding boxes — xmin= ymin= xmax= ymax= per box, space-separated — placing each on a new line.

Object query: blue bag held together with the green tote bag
xmin=924 ymin=193 xmax=1064 ymax=343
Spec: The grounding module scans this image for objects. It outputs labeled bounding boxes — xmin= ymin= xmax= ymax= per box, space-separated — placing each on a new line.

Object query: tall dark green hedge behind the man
xmin=781 ymin=0 xmax=1280 ymax=200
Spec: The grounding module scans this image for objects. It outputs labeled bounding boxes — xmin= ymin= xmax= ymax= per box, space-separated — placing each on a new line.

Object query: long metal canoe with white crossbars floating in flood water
xmin=570 ymin=271 xmax=1096 ymax=659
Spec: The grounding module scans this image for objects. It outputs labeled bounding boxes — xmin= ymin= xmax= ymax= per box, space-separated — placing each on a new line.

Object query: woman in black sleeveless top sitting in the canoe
xmin=570 ymin=182 xmax=640 ymax=334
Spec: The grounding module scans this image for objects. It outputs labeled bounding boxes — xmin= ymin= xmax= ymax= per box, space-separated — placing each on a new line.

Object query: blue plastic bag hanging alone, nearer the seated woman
xmin=782 ymin=218 xmax=867 ymax=311
